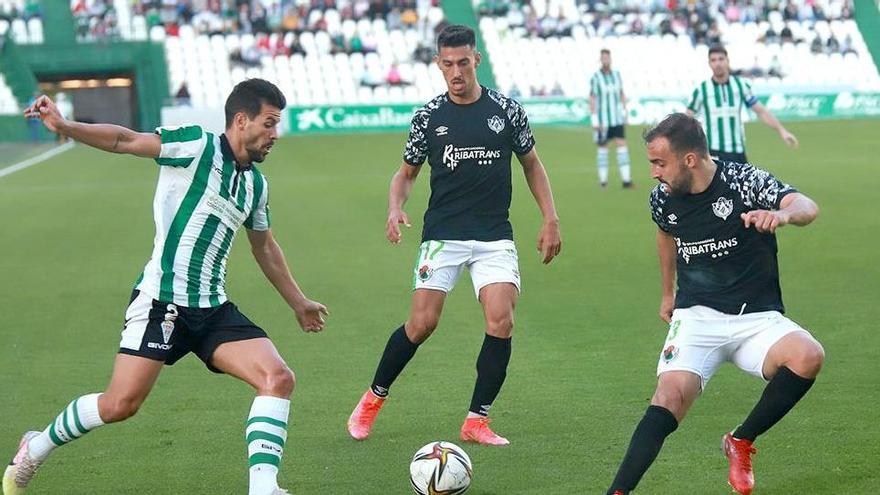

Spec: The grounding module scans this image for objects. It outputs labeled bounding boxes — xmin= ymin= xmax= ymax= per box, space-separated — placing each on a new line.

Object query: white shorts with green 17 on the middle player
xmin=413 ymin=239 xmax=520 ymax=299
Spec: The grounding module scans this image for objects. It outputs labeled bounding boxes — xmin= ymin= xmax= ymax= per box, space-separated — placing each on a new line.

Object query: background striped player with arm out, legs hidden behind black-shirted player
xmin=687 ymin=45 xmax=798 ymax=163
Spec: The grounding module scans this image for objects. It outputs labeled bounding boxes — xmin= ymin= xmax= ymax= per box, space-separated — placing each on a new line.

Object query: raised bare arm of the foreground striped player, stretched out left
xmin=24 ymin=95 xmax=162 ymax=158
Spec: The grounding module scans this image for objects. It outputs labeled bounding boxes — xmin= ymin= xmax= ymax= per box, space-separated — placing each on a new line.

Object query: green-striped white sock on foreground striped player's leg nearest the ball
xmin=245 ymin=395 xmax=290 ymax=495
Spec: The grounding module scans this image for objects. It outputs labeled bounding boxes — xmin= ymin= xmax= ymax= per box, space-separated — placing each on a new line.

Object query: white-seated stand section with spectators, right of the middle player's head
xmin=474 ymin=0 xmax=880 ymax=97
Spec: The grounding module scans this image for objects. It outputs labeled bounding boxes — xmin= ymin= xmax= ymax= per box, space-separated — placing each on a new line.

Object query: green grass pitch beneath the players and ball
xmin=0 ymin=120 xmax=880 ymax=495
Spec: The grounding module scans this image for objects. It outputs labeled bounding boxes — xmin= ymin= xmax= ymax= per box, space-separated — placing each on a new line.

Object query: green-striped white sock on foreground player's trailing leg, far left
xmin=28 ymin=394 xmax=104 ymax=461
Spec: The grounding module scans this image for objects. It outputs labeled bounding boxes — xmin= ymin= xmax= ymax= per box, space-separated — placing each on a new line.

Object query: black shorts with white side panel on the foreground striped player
xmin=119 ymin=290 xmax=267 ymax=373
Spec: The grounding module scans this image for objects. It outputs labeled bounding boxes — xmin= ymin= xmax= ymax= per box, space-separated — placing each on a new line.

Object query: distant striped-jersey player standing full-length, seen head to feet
xmin=590 ymin=48 xmax=632 ymax=188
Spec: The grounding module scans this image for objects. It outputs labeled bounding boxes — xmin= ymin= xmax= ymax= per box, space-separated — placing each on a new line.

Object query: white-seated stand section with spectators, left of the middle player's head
xmin=144 ymin=0 xmax=444 ymax=107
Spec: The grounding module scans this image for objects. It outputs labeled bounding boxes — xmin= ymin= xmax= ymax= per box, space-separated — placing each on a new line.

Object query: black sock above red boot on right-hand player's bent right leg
xmin=733 ymin=366 xmax=816 ymax=442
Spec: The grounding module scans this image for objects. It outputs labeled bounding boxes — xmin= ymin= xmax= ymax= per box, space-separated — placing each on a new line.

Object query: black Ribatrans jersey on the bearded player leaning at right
xmin=650 ymin=161 xmax=797 ymax=314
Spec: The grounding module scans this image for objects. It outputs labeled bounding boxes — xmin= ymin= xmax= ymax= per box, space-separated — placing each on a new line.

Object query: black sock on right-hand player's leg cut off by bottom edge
xmin=608 ymin=406 xmax=678 ymax=495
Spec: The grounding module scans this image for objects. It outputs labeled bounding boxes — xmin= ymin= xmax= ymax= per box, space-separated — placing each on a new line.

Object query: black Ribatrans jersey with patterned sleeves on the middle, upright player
xmin=403 ymin=87 xmax=535 ymax=241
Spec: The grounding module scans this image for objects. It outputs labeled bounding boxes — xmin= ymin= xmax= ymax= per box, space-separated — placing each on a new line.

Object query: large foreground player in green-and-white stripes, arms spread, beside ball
xmin=3 ymin=79 xmax=327 ymax=495
